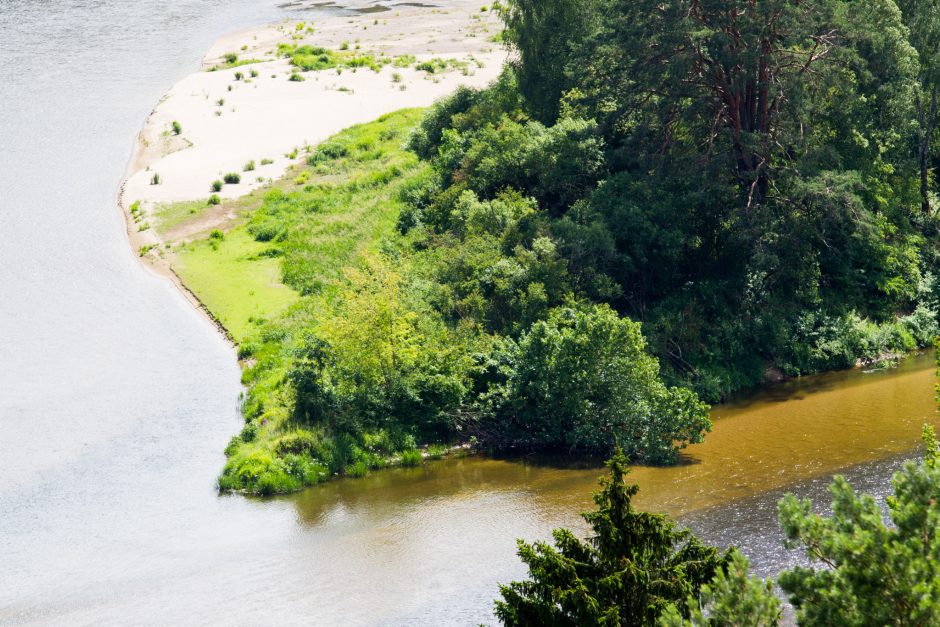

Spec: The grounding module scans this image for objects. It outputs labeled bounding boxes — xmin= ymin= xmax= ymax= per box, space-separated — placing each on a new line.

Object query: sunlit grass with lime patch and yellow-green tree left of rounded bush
xmin=197 ymin=111 xmax=465 ymax=494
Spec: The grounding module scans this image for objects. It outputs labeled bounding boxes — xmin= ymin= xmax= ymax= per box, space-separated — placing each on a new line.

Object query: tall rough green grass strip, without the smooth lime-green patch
xmin=219 ymin=111 xmax=446 ymax=494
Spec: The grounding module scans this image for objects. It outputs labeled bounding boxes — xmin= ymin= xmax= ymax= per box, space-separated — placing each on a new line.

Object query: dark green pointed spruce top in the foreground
xmin=496 ymin=451 xmax=728 ymax=625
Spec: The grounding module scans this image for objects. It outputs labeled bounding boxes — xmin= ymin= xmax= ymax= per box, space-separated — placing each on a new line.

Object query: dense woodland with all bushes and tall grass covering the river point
xmin=220 ymin=0 xmax=940 ymax=492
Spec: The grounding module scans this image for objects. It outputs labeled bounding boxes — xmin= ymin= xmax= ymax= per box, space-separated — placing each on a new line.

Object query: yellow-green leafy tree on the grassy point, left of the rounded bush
xmin=287 ymin=254 xmax=466 ymax=438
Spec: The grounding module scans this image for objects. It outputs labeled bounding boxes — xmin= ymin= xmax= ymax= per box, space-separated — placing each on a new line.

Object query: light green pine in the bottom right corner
xmin=779 ymin=425 xmax=940 ymax=625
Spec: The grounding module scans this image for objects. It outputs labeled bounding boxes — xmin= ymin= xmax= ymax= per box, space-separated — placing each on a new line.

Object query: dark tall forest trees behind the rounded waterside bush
xmin=410 ymin=0 xmax=938 ymax=400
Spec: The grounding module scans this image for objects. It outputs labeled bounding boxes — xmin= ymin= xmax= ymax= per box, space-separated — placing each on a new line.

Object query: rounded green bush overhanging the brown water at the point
xmin=482 ymin=306 xmax=711 ymax=463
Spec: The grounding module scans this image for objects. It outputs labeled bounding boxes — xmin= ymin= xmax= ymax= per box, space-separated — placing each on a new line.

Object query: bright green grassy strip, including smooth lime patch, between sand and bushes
xmin=174 ymin=110 xmax=427 ymax=493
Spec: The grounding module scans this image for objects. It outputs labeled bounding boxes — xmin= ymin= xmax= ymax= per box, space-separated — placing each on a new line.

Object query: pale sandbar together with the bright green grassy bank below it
xmin=119 ymin=1 xmax=506 ymax=493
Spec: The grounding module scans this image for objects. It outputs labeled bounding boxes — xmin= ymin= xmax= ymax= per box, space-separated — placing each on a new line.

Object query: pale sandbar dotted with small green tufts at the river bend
xmin=118 ymin=0 xmax=506 ymax=302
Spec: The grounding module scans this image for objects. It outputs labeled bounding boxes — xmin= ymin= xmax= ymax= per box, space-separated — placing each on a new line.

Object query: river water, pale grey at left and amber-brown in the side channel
xmin=0 ymin=0 xmax=933 ymax=625
